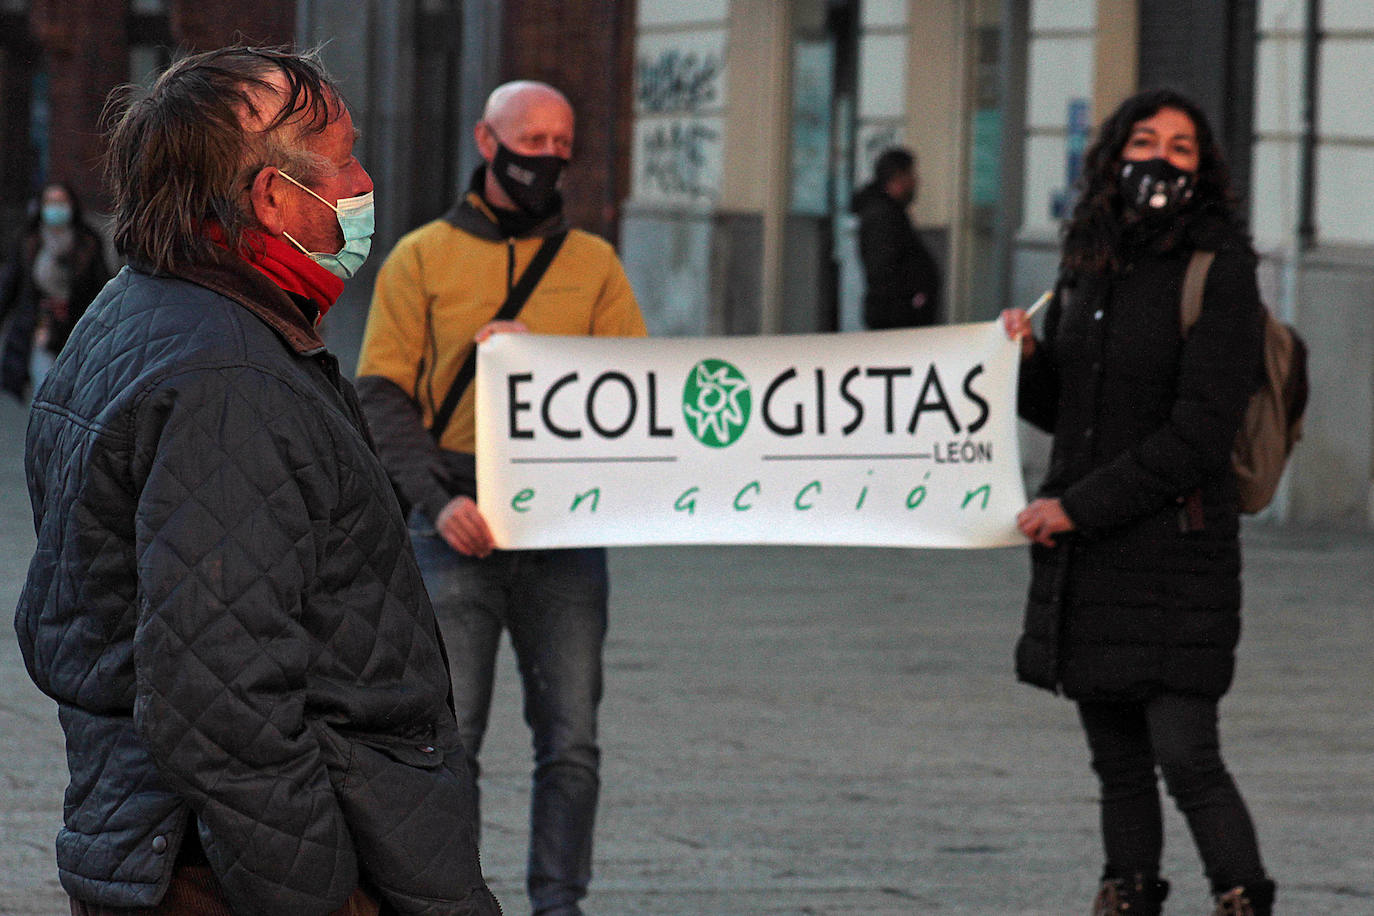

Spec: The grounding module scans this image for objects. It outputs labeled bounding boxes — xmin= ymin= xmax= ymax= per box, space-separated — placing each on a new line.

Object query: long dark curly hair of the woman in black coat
xmin=1062 ymin=89 xmax=1243 ymax=275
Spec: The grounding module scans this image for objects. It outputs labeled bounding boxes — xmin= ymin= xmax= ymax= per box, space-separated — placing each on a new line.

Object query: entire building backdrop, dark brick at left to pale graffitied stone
xmin=0 ymin=0 xmax=1374 ymax=529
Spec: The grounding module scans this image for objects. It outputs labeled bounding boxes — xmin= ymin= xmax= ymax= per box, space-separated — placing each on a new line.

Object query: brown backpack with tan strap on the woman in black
xmin=1179 ymin=251 xmax=1308 ymax=514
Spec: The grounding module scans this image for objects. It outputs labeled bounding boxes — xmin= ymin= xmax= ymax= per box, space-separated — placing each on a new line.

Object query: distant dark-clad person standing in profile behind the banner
xmin=849 ymin=147 xmax=940 ymax=330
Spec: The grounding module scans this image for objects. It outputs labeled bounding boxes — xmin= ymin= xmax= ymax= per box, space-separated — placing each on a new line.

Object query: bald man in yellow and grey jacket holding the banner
xmin=357 ymin=81 xmax=644 ymax=916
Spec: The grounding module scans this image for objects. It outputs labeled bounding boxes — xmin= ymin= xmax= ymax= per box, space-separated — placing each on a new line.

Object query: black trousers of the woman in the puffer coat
xmin=1079 ymin=694 xmax=1265 ymax=893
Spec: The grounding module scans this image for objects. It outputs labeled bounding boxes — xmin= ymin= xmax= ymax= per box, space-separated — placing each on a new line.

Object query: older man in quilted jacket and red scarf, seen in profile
xmin=16 ymin=48 xmax=497 ymax=916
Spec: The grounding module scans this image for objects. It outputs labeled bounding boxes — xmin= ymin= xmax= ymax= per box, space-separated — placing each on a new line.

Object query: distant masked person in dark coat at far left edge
xmin=0 ymin=181 xmax=110 ymax=401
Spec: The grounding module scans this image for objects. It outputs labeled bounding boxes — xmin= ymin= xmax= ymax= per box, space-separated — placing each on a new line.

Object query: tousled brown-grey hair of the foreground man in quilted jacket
xmin=104 ymin=45 xmax=342 ymax=271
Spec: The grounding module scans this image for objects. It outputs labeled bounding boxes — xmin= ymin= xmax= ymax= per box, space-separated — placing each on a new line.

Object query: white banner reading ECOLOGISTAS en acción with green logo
xmin=477 ymin=323 xmax=1025 ymax=548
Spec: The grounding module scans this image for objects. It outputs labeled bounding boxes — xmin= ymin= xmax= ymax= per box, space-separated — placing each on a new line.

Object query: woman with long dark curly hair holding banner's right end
xmin=1003 ymin=91 xmax=1274 ymax=916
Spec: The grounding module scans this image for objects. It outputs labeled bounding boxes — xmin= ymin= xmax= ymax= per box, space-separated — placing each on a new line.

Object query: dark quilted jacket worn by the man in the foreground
xmin=15 ymin=261 xmax=496 ymax=916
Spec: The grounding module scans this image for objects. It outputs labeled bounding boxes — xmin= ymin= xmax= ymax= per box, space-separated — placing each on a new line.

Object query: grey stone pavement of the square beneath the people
xmin=0 ymin=401 xmax=1374 ymax=916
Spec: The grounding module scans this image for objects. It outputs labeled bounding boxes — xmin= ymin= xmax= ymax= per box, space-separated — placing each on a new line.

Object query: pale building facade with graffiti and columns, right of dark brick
xmin=621 ymin=0 xmax=1374 ymax=529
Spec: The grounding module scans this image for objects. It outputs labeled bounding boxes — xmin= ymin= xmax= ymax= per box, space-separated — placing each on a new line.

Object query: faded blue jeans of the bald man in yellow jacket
xmin=411 ymin=522 xmax=607 ymax=916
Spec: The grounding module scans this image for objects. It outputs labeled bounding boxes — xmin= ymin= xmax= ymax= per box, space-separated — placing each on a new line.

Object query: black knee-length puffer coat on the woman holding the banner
xmin=1017 ymin=220 xmax=1263 ymax=699
